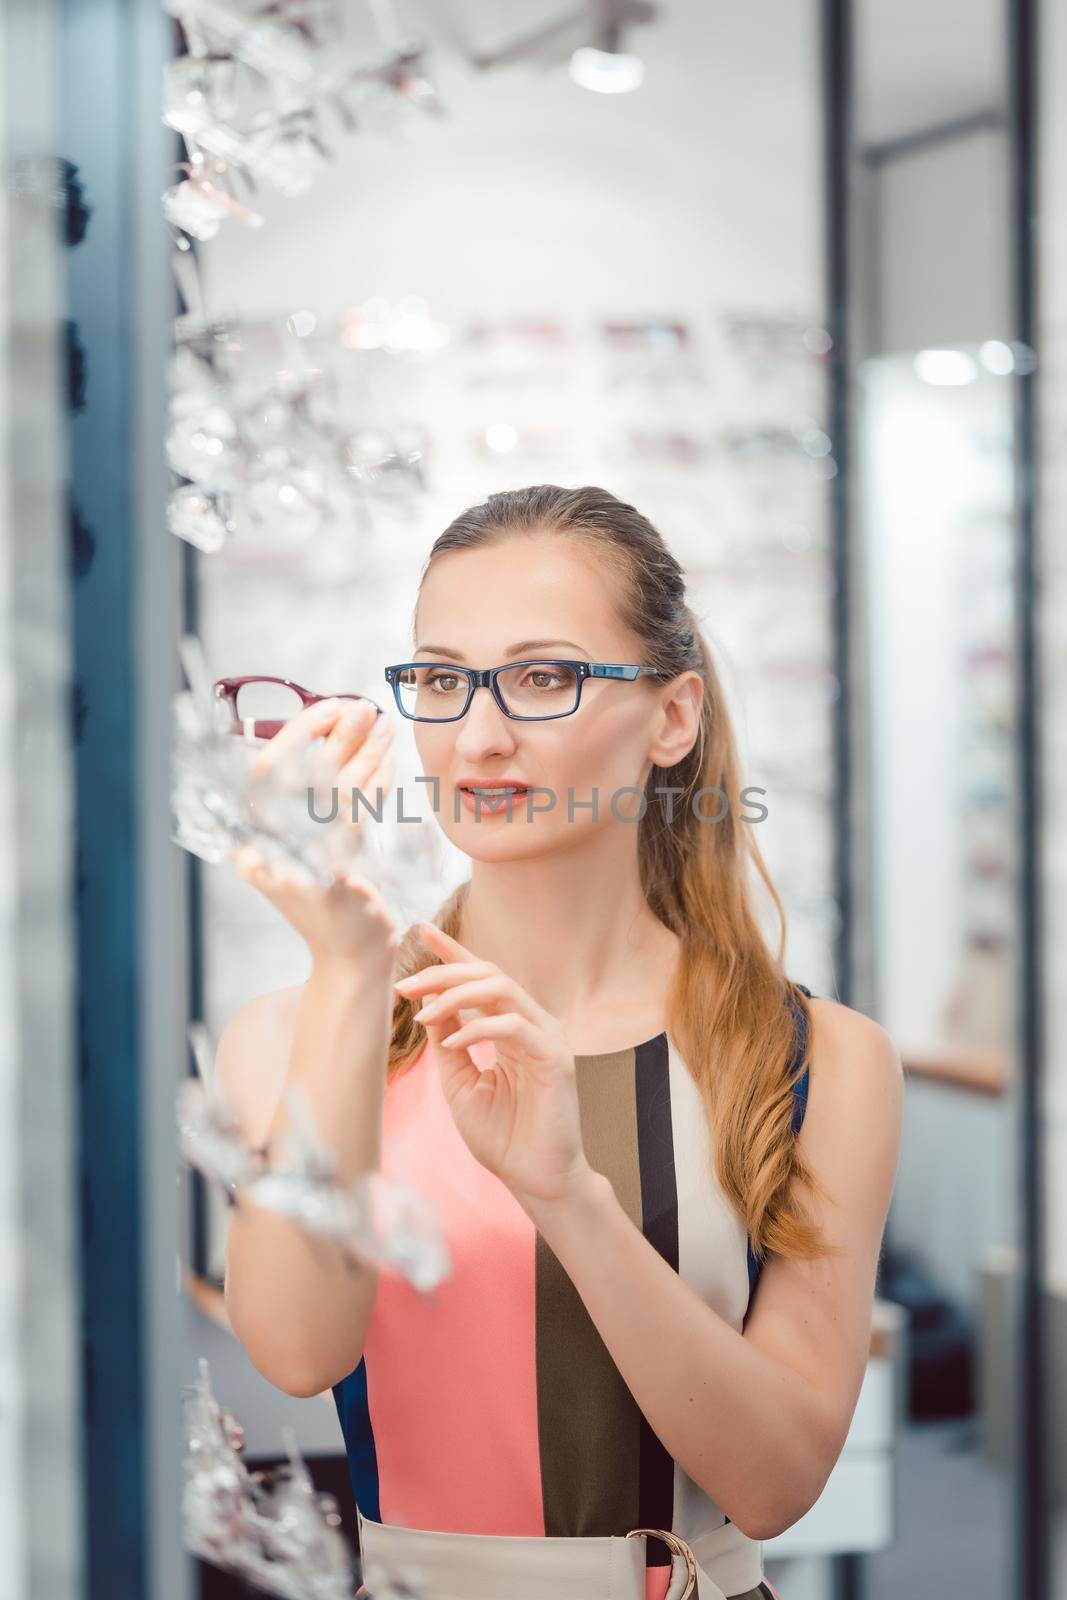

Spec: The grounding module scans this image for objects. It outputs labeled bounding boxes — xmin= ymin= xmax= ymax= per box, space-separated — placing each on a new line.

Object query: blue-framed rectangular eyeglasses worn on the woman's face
xmin=386 ymin=661 xmax=664 ymax=722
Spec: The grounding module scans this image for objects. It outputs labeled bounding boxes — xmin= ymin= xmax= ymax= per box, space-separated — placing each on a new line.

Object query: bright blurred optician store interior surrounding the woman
xmin=0 ymin=0 xmax=1067 ymax=1600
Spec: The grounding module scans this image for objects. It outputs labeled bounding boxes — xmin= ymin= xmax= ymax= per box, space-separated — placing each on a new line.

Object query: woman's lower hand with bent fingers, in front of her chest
xmin=395 ymin=922 xmax=590 ymax=1205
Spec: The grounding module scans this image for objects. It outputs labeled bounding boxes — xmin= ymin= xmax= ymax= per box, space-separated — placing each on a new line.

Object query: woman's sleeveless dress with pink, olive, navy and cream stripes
xmin=333 ymin=984 xmax=811 ymax=1600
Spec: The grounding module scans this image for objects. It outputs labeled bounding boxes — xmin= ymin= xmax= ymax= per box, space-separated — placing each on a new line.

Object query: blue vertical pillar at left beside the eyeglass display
xmin=58 ymin=0 xmax=184 ymax=1600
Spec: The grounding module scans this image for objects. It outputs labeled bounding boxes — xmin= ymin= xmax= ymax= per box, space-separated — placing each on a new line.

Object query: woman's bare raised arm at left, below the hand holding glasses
xmin=216 ymin=963 xmax=394 ymax=1395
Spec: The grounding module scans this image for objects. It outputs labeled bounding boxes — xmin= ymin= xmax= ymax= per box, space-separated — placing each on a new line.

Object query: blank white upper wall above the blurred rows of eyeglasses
xmin=205 ymin=0 xmax=822 ymax=326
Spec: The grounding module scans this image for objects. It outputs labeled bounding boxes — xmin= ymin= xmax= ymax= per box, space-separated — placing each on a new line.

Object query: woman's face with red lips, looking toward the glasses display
xmin=411 ymin=534 xmax=701 ymax=861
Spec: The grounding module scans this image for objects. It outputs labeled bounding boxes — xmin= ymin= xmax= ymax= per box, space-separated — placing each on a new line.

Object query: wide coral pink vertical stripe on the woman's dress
xmin=363 ymin=1040 xmax=550 ymax=1536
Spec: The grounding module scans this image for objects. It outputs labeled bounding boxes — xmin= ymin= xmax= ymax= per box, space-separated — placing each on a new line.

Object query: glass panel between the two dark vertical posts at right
xmin=851 ymin=0 xmax=1022 ymax=1600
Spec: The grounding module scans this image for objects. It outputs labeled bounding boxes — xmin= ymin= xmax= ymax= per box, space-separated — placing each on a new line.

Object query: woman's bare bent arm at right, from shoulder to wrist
xmin=526 ymin=1000 xmax=904 ymax=1539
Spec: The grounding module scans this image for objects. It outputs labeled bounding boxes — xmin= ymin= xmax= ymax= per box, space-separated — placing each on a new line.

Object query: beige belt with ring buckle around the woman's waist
xmin=357 ymin=1507 xmax=761 ymax=1600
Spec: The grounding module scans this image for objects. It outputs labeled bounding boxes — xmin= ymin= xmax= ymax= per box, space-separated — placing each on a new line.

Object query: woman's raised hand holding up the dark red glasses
xmin=229 ymin=699 xmax=400 ymax=970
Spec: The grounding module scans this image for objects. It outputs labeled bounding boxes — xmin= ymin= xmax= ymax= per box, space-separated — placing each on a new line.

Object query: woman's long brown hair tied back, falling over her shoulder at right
xmin=389 ymin=483 xmax=837 ymax=1258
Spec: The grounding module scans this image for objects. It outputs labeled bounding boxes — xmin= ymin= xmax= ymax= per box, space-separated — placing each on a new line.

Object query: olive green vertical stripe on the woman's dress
xmin=534 ymin=1050 xmax=641 ymax=1538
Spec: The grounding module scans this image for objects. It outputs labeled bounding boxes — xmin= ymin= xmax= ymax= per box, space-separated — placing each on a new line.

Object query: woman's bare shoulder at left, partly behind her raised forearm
xmin=214 ymin=984 xmax=304 ymax=1146
